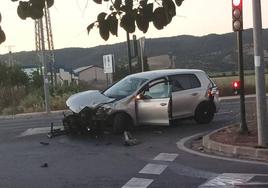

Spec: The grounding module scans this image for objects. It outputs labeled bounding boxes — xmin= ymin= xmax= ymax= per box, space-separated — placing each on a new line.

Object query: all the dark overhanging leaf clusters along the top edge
xmin=0 ymin=0 xmax=184 ymax=44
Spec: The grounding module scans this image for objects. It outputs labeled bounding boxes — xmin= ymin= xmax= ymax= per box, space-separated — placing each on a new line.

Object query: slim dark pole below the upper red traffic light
xmin=236 ymin=30 xmax=248 ymax=134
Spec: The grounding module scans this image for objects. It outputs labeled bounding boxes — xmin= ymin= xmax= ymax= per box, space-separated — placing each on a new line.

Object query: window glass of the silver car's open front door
xmin=143 ymin=79 xmax=171 ymax=99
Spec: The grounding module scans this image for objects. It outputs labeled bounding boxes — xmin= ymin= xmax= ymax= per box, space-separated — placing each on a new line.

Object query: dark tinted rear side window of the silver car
xmin=170 ymin=74 xmax=201 ymax=92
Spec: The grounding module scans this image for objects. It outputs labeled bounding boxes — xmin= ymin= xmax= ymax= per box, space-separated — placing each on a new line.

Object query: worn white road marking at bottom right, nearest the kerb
xmin=199 ymin=173 xmax=255 ymax=188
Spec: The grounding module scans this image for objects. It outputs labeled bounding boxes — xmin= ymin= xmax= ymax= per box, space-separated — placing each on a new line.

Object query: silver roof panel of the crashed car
xmin=131 ymin=69 xmax=204 ymax=80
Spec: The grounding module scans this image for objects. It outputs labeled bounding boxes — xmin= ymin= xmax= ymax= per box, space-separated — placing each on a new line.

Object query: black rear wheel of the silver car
xmin=194 ymin=102 xmax=214 ymax=124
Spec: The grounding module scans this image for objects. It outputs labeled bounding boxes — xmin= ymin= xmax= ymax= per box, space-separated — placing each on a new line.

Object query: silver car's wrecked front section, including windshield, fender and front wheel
xmin=63 ymin=75 xmax=148 ymax=133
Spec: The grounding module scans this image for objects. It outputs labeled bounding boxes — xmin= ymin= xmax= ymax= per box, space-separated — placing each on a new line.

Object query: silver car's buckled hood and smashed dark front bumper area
xmin=63 ymin=90 xmax=115 ymax=133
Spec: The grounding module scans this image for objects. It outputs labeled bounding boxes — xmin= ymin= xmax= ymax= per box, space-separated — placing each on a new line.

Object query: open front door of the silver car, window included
xmin=136 ymin=79 xmax=171 ymax=125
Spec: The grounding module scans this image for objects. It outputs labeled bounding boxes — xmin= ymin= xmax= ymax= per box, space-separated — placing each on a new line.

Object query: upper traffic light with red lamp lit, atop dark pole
xmin=232 ymin=0 xmax=243 ymax=31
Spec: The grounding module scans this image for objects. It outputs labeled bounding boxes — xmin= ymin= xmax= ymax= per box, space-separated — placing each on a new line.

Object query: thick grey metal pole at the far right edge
xmin=252 ymin=0 xmax=268 ymax=146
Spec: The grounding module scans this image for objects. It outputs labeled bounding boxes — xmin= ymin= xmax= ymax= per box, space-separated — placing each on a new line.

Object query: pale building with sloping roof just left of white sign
xmin=73 ymin=65 xmax=106 ymax=83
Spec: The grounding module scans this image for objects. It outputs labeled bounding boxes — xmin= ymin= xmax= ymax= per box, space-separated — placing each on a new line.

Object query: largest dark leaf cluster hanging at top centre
xmin=87 ymin=0 xmax=183 ymax=40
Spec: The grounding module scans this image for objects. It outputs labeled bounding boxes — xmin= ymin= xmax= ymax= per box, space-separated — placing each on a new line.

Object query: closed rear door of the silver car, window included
xmin=170 ymin=74 xmax=202 ymax=119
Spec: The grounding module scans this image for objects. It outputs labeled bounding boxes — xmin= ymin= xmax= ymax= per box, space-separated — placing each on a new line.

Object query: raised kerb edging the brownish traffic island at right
xmin=202 ymin=125 xmax=268 ymax=162
